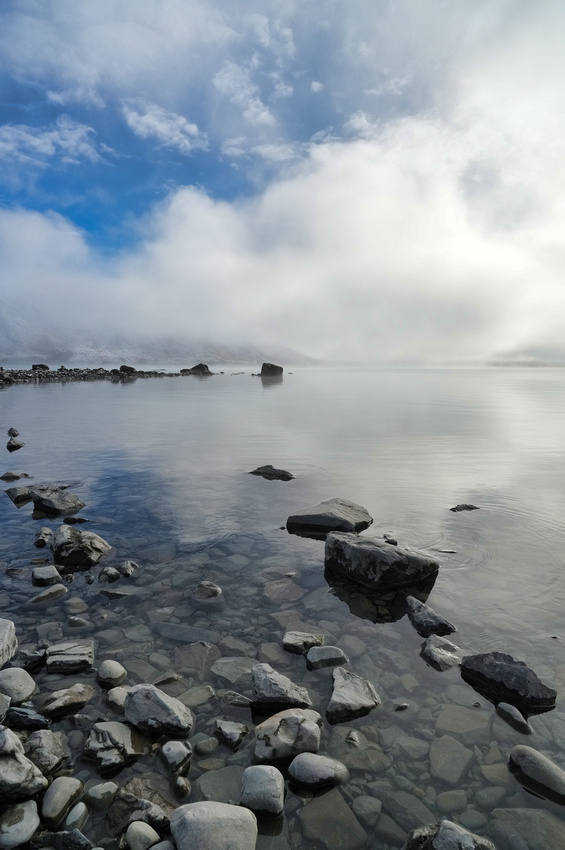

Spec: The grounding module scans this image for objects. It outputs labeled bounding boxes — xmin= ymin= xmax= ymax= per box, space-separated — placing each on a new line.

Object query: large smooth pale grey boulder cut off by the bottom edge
xmin=170 ymin=802 xmax=257 ymax=850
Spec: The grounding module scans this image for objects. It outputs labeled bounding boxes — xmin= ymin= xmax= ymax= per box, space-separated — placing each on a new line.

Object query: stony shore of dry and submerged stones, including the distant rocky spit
xmin=0 ymin=367 xmax=565 ymax=850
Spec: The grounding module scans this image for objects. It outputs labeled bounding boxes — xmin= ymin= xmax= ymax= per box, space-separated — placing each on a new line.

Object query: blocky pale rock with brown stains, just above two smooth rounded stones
xmin=255 ymin=708 xmax=322 ymax=762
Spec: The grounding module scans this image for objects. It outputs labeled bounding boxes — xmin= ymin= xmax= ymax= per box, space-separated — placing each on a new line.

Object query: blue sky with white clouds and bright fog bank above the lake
xmin=0 ymin=0 xmax=565 ymax=364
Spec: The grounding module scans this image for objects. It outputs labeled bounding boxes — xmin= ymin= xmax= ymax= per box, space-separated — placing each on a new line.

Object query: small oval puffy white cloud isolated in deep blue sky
xmin=123 ymin=102 xmax=208 ymax=154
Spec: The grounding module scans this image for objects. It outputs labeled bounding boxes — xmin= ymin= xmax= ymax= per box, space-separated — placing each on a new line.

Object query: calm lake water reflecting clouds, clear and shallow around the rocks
xmin=0 ymin=367 xmax=565 ymax=848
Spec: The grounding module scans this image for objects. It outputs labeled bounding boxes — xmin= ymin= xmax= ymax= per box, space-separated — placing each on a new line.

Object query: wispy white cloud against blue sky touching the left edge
xmin=0 ymin=115 xmax=102 ymax=165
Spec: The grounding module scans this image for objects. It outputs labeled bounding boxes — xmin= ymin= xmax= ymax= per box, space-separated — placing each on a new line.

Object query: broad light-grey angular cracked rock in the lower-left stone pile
xmin=124 ymin=684 xmax=194 ymax=738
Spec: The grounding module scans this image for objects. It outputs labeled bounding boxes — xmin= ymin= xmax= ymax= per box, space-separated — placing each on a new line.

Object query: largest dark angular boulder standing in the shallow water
xmin=325 ymin=531 xmax=439 ymax=590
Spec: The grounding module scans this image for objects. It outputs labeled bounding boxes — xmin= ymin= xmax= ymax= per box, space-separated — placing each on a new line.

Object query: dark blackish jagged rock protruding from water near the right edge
xmin=461 ymin=652 xmax=557 ymax=714
